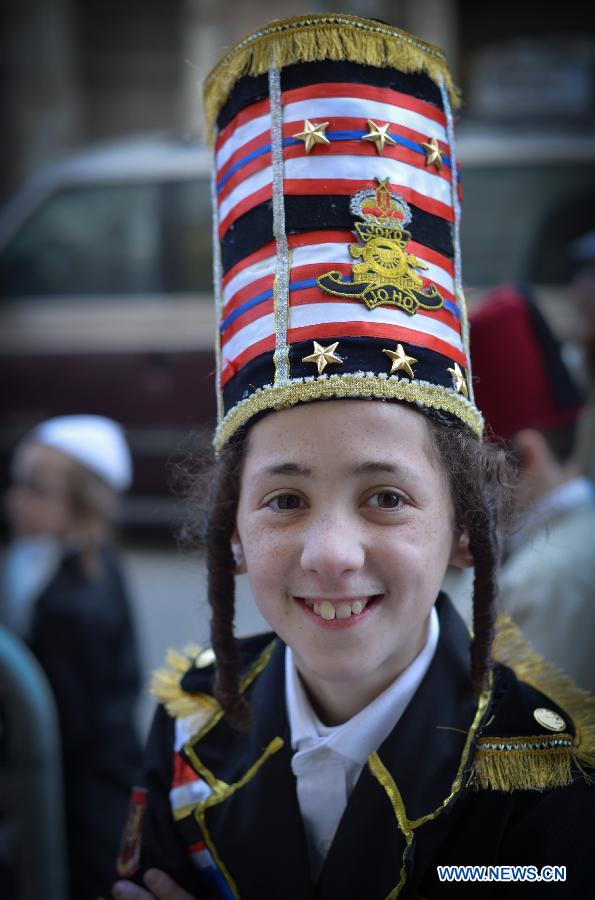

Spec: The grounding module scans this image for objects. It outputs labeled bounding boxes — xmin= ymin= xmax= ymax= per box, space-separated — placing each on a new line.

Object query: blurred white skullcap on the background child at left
xmin=32 ymin=416 xmax=132 ymax=491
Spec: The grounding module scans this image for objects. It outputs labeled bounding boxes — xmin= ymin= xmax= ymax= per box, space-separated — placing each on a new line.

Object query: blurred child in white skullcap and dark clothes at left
xmin=0 ymin=416 xmax=140 ymax=900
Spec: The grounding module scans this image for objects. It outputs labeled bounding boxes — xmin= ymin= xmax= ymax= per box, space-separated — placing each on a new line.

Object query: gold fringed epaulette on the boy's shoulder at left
xmin=149 ymin=644 xmax=219 ymax=719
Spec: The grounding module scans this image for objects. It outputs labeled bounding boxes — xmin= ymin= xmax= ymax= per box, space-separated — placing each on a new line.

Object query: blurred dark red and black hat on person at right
xmin=470 ymin=284 xmax=584 ymax=440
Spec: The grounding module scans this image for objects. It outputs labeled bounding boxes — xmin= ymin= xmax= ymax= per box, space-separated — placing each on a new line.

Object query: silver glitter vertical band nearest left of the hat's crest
xmin=269 ymin=66 xmax=289 ymax=385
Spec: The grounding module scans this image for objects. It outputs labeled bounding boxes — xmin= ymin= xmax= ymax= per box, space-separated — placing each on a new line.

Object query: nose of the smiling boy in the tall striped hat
xmin=301 ymin=517 xmax=365 ymax=578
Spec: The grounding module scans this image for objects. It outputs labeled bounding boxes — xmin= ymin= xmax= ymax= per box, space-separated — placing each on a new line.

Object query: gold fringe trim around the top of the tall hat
xmin=204 ymin=13 xmax=460 ymax=139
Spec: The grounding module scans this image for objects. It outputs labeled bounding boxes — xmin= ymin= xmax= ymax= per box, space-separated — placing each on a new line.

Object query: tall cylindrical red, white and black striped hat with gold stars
xmin=205 ymin=14 xmax=482 ymax=450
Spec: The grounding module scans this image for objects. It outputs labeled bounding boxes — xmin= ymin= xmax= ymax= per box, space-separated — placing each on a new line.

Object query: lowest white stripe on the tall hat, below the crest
xmin=222 ymin=303 xmax=462 ymax=361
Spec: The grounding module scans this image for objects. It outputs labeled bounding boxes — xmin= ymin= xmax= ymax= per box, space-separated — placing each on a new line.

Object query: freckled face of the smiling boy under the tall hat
xmin=233 ymin=400 xmax=467 ymax=720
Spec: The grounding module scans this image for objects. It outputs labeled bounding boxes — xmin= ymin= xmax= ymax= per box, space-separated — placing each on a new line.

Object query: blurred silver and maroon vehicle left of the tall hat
xmin=0 ymin=136 xmax=215 ymax=524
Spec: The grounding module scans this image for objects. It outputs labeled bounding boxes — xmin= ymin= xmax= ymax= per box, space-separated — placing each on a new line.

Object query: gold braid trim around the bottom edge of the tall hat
xmin=214 ymin=372 xmax=483 ymax=452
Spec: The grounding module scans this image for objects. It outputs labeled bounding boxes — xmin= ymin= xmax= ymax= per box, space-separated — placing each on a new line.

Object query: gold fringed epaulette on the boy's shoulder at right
xmin=472 ymin=616 xmax=595 ymax=791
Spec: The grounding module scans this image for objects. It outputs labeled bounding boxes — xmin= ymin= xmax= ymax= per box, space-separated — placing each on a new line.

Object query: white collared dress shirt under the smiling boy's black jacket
xmin=285 ymin=607 xmax=440 ymax=878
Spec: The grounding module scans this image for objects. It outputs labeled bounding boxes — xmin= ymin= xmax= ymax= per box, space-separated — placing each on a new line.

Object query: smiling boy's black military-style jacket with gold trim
xmin=130 ymin=596 xmax=595 ymax=900
